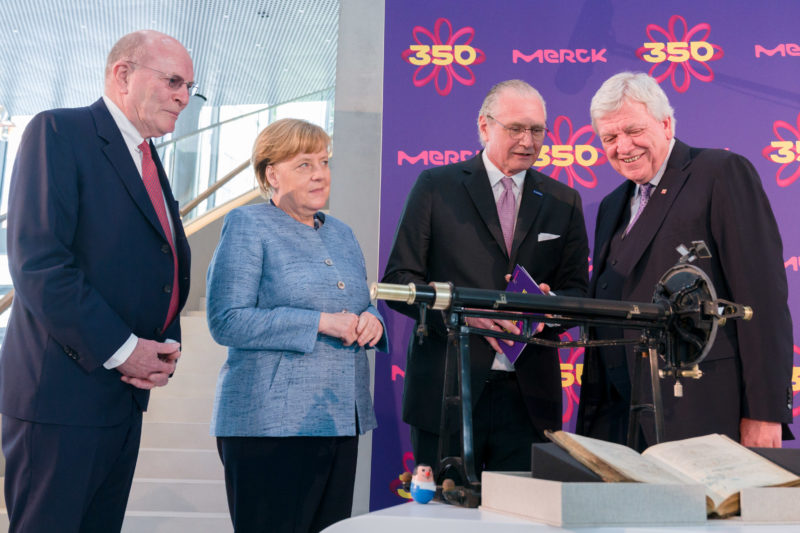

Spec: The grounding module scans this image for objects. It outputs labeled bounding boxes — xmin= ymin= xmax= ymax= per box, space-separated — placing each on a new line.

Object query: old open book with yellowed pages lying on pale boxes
xmin=545 ymin=431 xmax=800 ymax=517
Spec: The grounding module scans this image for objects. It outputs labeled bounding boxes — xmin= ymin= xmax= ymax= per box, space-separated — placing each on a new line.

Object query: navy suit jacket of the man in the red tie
xmin=0 ymin=99 xmax=189 ymax=426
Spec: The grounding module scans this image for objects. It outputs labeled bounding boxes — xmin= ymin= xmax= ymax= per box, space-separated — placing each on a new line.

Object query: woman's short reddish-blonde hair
xmin=250 ymin=118 xmax=331 ymax=197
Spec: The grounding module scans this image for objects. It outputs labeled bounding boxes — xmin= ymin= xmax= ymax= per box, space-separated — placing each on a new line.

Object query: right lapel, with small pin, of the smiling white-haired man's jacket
xmin=626 ymin=139 xmax=690 ymax=274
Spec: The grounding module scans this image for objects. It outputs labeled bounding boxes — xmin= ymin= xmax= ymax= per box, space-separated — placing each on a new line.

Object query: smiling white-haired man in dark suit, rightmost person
xmin=578 ymin=72 xmax=792 ymax=447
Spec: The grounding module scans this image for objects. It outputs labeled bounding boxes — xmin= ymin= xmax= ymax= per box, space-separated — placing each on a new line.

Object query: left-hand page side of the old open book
xmin=550 ymin=431 xmax=696 ymax=485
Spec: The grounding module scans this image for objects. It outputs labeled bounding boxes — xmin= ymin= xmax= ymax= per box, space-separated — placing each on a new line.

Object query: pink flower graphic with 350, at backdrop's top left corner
xmin=402 ymin=18 xmax=486 ymax=96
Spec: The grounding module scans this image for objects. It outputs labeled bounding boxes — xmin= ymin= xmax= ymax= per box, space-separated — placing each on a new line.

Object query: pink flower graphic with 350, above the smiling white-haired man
xmin=636 ymin=15 xmax=725 ymax=93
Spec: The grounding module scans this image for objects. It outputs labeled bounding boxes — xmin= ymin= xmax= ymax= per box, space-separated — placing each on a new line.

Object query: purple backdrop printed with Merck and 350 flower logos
xmin=370 ymin=0 xmax=800 ymax=510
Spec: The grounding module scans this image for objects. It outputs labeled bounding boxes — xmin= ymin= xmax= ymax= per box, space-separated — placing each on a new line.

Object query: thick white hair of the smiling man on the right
xmin=589 ymin=72 xmax=675 ymax=135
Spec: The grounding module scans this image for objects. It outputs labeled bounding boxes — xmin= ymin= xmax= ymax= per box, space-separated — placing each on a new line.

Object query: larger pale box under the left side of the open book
xmin=481 ymin=472 xmax=706 ymax=527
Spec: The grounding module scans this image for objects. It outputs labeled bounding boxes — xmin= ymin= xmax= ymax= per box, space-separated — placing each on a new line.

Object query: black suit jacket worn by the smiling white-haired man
xmin=578 ymin=141 xmax=792 ymax=444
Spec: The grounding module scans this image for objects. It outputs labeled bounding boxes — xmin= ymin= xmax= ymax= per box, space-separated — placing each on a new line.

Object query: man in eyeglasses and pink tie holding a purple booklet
xmin=383 ymin=80 xmax=589 ymax=474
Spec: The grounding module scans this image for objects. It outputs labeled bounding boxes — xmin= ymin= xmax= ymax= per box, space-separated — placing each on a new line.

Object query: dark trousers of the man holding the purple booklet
xmin=411 ymin=371 xmax=543 ymax=482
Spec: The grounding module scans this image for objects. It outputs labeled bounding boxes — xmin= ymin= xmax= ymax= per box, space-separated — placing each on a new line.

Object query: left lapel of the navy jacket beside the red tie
xmin=89 ymin=98 xmax=166 ymax=238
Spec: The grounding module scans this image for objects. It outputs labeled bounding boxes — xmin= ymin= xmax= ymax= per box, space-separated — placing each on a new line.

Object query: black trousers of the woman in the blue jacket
xmin=217 ymin=436 xmax=358 ymax=533
